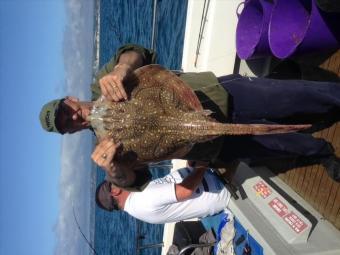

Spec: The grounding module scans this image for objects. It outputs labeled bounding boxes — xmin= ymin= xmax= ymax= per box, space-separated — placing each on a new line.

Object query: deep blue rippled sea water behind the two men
xmin=95 ymin=0 xmax=187 ymax=255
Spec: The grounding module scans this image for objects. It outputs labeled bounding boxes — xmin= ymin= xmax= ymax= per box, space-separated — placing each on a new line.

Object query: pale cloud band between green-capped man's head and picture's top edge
xmin=63 ymin=0 xmax=94 ymax=99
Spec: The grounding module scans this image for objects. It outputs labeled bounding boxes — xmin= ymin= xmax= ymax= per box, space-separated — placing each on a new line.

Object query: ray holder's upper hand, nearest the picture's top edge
xmin=99 ymin=64 xmax=132 ymax=102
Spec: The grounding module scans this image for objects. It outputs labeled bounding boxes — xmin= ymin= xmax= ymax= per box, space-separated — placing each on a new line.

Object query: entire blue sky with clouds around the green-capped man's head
xmin=0 ymin=0 xmax=95 ymax=255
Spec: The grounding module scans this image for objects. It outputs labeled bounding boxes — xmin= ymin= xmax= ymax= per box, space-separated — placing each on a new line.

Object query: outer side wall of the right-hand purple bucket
xmin=297 ymin=0 xmax=340 ymax=54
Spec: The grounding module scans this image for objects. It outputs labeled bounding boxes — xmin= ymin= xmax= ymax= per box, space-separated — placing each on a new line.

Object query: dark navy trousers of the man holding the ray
xmin=218 ymin=75 xmax=340 ymax=162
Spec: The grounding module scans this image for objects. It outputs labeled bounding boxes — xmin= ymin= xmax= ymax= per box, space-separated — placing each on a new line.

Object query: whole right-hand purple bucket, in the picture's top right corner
xmin=268 ymin=0 xmax=340 ymax=59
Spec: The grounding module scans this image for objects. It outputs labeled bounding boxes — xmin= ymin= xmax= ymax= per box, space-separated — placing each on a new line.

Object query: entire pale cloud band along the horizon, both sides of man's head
xmin=55 ymin=0 xmax=95 ymax=255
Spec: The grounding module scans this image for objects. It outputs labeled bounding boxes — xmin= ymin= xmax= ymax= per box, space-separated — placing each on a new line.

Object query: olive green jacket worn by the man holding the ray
xmin=91 ymin=44 xmax=228 ymax=189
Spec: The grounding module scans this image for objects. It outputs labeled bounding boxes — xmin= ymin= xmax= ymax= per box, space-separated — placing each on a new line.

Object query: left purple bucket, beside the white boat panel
xmin=236 ymin=0 xmax=273 ymax=59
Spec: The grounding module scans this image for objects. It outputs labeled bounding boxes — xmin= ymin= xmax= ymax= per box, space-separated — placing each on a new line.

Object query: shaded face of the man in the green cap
xmin=56 ymin=97 xmax=90 ymax=134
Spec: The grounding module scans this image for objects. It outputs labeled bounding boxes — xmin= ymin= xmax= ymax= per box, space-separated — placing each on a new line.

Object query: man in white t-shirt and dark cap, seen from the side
xmin=96 ymin=163 xmax=230 ymax=224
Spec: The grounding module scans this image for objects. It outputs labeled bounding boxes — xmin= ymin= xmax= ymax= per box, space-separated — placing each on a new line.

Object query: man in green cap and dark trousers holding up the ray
xmin=40 ymin=42 xmax=340 ymax=188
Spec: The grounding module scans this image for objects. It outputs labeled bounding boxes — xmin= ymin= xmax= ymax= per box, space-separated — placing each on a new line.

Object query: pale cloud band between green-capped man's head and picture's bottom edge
xmin=56 ymin=131 xmax=95 ymax=254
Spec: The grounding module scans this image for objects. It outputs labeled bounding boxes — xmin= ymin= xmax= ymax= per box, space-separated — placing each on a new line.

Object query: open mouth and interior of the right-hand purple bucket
xmin=268 ymin=0 xmax=310 ymax=59
